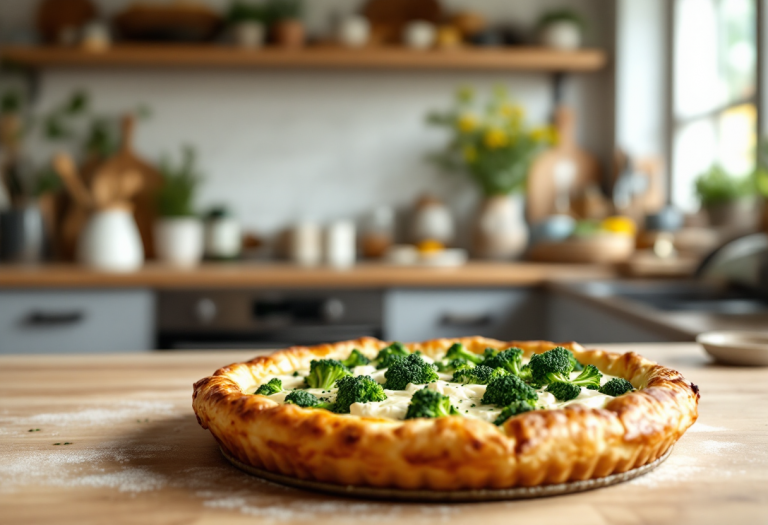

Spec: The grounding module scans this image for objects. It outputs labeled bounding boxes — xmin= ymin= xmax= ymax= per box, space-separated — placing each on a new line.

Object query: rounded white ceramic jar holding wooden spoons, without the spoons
xmin=77 ymin=208 xmax=144 ymax=272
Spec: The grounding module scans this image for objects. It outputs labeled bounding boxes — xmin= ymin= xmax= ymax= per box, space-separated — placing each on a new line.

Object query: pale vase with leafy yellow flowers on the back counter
xmin=429 ymin=88 xmax=554 ymax=259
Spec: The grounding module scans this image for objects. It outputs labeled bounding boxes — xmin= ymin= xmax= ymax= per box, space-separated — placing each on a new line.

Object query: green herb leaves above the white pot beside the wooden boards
xmin=157 ymin=146 xmax=203 ymax=217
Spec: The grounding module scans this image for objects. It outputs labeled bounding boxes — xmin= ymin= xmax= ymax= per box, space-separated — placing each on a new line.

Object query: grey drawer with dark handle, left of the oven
xmin=0 ymin=289 xmax=155 ymax=354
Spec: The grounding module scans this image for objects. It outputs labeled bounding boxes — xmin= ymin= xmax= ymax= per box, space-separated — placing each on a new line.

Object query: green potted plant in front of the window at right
xmin=695 ymin=164 xmax=756 ymax=227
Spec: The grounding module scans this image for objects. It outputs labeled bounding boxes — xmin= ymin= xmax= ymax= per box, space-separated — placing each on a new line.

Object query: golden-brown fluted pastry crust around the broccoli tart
xmin=192 ymin=337 xmax=699 ymax=490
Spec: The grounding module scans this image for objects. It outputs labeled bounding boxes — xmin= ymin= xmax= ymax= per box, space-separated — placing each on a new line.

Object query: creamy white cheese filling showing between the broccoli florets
xmin=253 ymin=356 xmax=613 ymax=423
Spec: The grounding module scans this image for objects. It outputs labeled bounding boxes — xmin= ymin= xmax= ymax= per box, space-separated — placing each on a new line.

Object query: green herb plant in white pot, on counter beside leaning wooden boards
xmin=155 ymin=147 xmax=203 ymax=267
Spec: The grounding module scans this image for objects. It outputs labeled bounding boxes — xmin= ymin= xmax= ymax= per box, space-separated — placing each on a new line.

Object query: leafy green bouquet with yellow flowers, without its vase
xmin=427 ymin=88 xmax=555 ymax=196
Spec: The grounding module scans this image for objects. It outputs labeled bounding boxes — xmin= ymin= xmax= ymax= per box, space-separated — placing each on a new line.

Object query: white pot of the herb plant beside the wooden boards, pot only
xmin=155 ymin=217 xmax=203 ymax=268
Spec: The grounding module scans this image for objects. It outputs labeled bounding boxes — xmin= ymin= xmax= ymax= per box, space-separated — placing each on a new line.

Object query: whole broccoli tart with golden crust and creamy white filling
xmin=193 ymin=337 xmax=699 ymax=490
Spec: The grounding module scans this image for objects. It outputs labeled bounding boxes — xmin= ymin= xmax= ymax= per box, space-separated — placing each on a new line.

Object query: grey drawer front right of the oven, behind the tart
xmin=384 ymin=288 xmax=546 ymax=341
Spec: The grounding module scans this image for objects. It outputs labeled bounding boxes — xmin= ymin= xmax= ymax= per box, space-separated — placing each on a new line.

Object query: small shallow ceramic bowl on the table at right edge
xmin=696 ymin=331 xmax=768 ymax=366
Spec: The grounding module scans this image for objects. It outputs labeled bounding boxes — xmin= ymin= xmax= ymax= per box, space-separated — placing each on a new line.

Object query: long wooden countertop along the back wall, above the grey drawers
xmin=0 ymin=262 xmax=615 ymax=289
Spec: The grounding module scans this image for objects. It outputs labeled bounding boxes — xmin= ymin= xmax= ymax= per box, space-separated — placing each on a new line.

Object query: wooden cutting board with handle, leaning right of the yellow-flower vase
xmin=526 ymin=106 xmax=600 ymax=224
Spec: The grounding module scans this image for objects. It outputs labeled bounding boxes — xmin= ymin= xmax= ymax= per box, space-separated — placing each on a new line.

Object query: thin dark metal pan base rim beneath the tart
xmin=219 ymin=447 xmax=674 ymax=503
